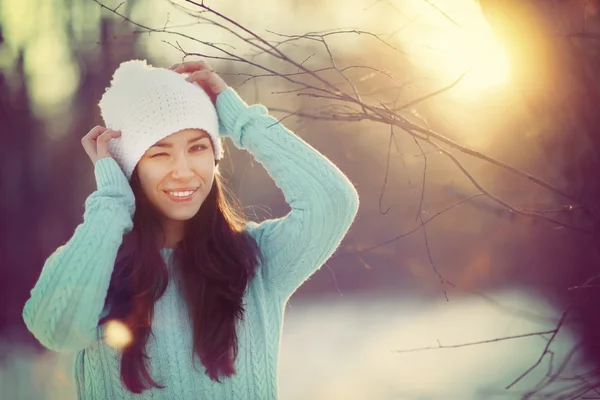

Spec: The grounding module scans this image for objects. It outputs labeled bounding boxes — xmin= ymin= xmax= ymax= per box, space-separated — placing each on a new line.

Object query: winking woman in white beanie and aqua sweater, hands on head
xmin=23 ymin=60 xmax=358 ymax=400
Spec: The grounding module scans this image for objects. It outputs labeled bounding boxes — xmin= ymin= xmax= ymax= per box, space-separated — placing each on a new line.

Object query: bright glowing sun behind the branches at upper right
xmin=401 ymin=0 xmax=510 ymax=92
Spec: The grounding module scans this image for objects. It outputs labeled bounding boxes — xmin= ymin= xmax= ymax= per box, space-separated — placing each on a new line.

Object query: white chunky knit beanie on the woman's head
xmin=98 ymin=60 xmax=223 ymax=179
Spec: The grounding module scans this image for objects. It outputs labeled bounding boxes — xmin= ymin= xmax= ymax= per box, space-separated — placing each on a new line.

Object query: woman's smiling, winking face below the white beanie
xmin=137 ymin=129 xmax=216 ymax=222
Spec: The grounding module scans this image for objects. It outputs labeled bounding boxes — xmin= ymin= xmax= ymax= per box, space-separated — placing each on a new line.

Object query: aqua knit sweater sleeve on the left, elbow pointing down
xmin=23 ymin=157 xmax=135 ymax=351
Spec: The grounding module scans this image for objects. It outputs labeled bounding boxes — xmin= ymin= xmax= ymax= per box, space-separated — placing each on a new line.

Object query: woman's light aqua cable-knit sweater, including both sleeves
xmin=23 ymin=88 xmax=358 ymax=400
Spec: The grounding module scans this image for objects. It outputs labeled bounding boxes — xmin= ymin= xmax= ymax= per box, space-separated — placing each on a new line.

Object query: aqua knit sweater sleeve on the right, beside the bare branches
xmin=217 ymin=88 xmax=359 ymax=299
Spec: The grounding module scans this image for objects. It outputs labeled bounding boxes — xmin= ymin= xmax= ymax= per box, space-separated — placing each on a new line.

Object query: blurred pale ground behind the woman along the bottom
xmin=0 ymin=290 xmax=576 ymax=400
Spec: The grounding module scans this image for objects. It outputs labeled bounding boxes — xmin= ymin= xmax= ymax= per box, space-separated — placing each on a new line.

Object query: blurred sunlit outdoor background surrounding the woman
xmin=0 ymin=0 xmax=600 ymax=400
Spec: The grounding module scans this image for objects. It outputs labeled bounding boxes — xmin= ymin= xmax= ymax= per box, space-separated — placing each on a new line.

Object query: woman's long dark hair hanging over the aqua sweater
xmin=99 ymin=169 xmax=261 ymax=393
